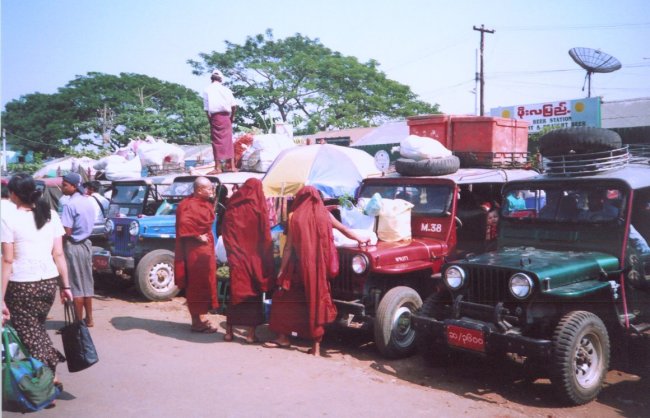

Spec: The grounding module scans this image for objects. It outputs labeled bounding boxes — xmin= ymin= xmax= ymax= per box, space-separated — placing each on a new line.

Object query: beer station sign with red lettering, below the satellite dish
xmin=490 ymin=97 xmax=601 ymax=133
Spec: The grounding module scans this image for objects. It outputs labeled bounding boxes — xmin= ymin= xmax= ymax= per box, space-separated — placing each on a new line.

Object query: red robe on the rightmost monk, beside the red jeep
xmin=269 ymin=186 xmax=338 ymax=341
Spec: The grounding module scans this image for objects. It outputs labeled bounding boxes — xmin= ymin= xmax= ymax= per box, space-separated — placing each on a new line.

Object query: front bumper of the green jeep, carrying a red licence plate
xmin=411 ymin=313 xmax=552 ymax=359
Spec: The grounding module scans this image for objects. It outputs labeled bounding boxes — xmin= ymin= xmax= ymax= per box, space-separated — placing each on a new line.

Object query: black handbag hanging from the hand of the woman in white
xmin=60 ymin=302 xmax=99 ymax=373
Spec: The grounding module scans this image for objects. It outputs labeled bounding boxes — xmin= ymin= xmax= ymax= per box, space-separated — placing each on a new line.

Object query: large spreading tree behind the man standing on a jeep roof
xmin=188 ymin=29 xmax=439 ymax=133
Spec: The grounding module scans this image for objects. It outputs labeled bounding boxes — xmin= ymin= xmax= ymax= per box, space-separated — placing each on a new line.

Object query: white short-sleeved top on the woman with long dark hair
xmin=0 ymin=209 xmax=65 ymax=282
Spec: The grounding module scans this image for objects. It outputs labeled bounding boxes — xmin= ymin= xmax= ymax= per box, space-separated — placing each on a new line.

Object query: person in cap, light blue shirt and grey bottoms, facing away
xmin=61 ymin=173 xmax=95 ymax=327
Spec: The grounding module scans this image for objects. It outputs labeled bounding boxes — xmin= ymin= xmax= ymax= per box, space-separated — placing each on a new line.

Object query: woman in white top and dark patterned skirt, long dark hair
xmin=0 ymin=173 xmax=72 ymax=396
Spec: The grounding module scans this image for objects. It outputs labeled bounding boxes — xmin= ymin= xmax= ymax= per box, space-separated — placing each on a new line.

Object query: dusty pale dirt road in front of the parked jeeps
xmin=2 ymin=280 xmax=650 ymax=418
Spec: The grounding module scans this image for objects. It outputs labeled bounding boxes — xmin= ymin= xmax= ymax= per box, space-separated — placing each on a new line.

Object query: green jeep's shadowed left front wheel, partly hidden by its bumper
xmin=415 ymin=291 xmax=452 ymax=367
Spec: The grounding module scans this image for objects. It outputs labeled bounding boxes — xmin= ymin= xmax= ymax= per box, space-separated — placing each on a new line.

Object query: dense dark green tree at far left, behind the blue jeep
xmin=2 ymin=72 xmax=209 ymax=157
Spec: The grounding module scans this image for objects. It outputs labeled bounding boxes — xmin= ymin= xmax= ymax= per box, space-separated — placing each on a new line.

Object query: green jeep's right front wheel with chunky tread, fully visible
xmin=550 ymin=311 xmax=609 ymax=405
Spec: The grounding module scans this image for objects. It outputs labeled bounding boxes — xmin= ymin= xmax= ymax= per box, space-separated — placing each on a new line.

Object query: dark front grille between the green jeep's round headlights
xmin=463 ymin=265 xmax=514 ymax=305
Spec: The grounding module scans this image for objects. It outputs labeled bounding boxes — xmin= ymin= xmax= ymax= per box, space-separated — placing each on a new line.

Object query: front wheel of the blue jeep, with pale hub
xmin=135 ymin=250 xmax=179 ymax=301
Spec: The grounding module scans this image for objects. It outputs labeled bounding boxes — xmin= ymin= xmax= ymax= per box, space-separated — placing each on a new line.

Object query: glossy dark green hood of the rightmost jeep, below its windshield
xmin=465 ymin=247 xmax=619 ymax=288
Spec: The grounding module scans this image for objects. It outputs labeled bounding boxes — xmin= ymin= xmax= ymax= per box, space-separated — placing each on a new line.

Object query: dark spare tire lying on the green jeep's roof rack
xmin=539 ymin=126 xmax=622 ymax=157
